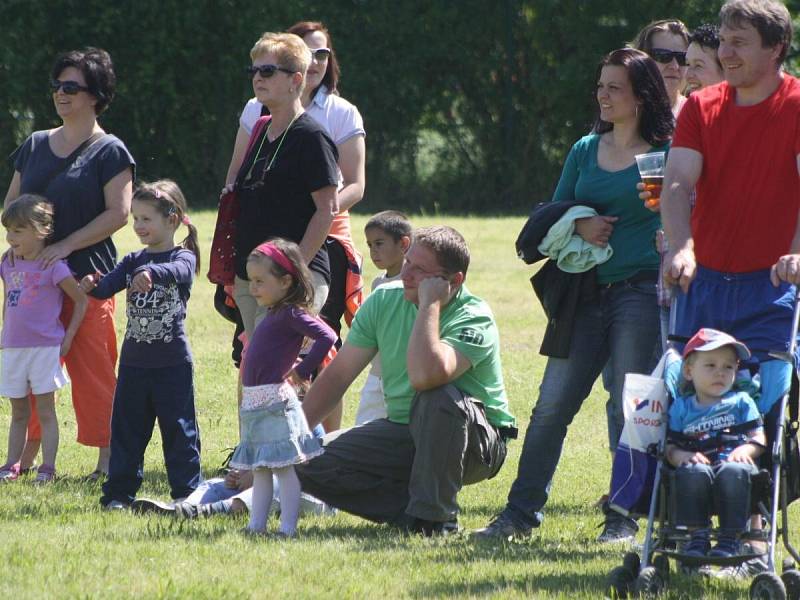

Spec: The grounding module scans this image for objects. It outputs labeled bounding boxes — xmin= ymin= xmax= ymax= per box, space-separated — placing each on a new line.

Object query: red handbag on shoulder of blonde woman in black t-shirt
xmin=208 ymin=116 xmax=270 ymax=285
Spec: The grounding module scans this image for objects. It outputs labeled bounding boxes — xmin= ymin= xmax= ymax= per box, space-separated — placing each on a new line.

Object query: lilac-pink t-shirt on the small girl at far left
xmin=0 ymin=258 xmax=72 ymax=348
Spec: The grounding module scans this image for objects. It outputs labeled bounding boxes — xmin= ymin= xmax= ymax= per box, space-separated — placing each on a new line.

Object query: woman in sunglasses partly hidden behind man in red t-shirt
xmin=631 ymin=19 xmax=689 ymax=117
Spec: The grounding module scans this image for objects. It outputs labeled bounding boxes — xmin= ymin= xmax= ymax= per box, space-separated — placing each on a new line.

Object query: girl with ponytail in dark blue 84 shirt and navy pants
xmin=81 ymin=179 xmax=201 ymax=509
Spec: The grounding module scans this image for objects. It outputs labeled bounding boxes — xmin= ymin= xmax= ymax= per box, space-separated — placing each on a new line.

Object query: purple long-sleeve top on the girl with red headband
xmin=242 ymin=306 xmax=336 ymax=386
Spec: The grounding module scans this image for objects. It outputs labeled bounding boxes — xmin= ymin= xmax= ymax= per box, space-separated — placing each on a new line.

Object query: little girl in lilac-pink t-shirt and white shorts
xmin=0 ymin=194 xmax=88 ymax=483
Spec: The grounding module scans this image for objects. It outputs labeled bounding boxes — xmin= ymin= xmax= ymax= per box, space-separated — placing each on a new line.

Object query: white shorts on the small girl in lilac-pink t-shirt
xmin=0 ymin=346 xmax=69 ymax=398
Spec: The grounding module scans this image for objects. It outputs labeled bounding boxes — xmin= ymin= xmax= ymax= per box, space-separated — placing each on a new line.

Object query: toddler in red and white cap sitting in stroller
xmin=665 ymin=329 xmax=766 ymax=558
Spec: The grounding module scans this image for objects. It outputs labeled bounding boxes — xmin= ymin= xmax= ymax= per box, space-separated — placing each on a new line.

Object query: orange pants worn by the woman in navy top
xmin=28 ymin=296 xmax=117 ymax=448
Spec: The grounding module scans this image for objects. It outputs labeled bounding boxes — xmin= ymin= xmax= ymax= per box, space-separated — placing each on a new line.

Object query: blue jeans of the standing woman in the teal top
xmin=504 ymin=282 xmax=661 ymax=527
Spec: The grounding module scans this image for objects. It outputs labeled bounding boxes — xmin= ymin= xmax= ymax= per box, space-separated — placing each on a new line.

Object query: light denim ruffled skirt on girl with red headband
xmin=230 ymin=382 xmax=323 ymax=470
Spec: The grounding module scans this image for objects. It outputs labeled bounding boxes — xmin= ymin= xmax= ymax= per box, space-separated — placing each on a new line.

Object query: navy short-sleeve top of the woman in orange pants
xmin=11 ymin=131 xmax=136 ymax=277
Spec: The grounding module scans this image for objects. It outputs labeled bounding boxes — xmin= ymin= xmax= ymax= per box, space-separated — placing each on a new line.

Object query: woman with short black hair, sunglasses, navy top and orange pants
xmin=5 ymin=48 xmax=135 ymax=480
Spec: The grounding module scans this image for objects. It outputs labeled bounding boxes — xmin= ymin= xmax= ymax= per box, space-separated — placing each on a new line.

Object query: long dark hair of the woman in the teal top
xmin=592 ymin=48 xmax=675 ymax=146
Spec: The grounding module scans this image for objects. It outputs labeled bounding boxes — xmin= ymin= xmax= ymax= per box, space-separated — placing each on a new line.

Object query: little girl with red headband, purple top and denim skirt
xmin=230 ymin=238 xmax=336 ymax=537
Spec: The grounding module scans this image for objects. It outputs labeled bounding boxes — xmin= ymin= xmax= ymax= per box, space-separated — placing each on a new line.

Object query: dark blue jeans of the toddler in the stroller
xmin=670 ymin=462 xmax=758 ymax=535
